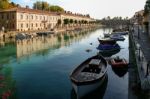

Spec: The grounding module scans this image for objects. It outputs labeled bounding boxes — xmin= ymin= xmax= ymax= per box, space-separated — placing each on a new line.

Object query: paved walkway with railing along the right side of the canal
xmin=130 ymin=26 xmax=150 ymax=90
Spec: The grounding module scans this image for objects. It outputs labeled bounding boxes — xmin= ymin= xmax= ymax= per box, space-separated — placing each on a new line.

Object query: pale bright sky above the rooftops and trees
xmin=11 ymin=0 xmax=146 ymax=19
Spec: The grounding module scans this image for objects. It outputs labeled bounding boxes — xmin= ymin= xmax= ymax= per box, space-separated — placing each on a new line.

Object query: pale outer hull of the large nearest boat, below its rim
xmin=72 ymin=75 xmax=106 ymax=99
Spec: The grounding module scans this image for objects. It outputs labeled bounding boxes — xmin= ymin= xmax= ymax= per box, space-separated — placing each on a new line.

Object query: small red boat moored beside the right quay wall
xmin=110 ymin=57 xmax=128 ymax=68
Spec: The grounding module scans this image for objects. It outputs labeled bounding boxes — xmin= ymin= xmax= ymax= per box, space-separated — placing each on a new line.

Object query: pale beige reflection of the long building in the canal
xmin=16 ymin=31 xmax=91 ymax=58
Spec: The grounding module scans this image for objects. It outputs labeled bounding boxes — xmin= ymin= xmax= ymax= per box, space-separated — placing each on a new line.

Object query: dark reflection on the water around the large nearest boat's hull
xmin=71 ymin=75 xmax=108 ymax=99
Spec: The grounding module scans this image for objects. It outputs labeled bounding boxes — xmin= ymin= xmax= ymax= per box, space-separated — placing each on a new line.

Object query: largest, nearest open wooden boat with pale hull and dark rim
xmin=70 ymin=55 xmax=107 ymax=98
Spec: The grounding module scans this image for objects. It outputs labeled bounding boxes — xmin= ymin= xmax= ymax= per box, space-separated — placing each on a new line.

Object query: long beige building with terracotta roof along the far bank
xmin=0 ymin=8 xmax=94 ymax=31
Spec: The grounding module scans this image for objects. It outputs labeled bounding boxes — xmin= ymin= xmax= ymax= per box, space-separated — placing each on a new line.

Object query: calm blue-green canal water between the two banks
xmin=0 ymin=29 xmax=129 ymax=99
